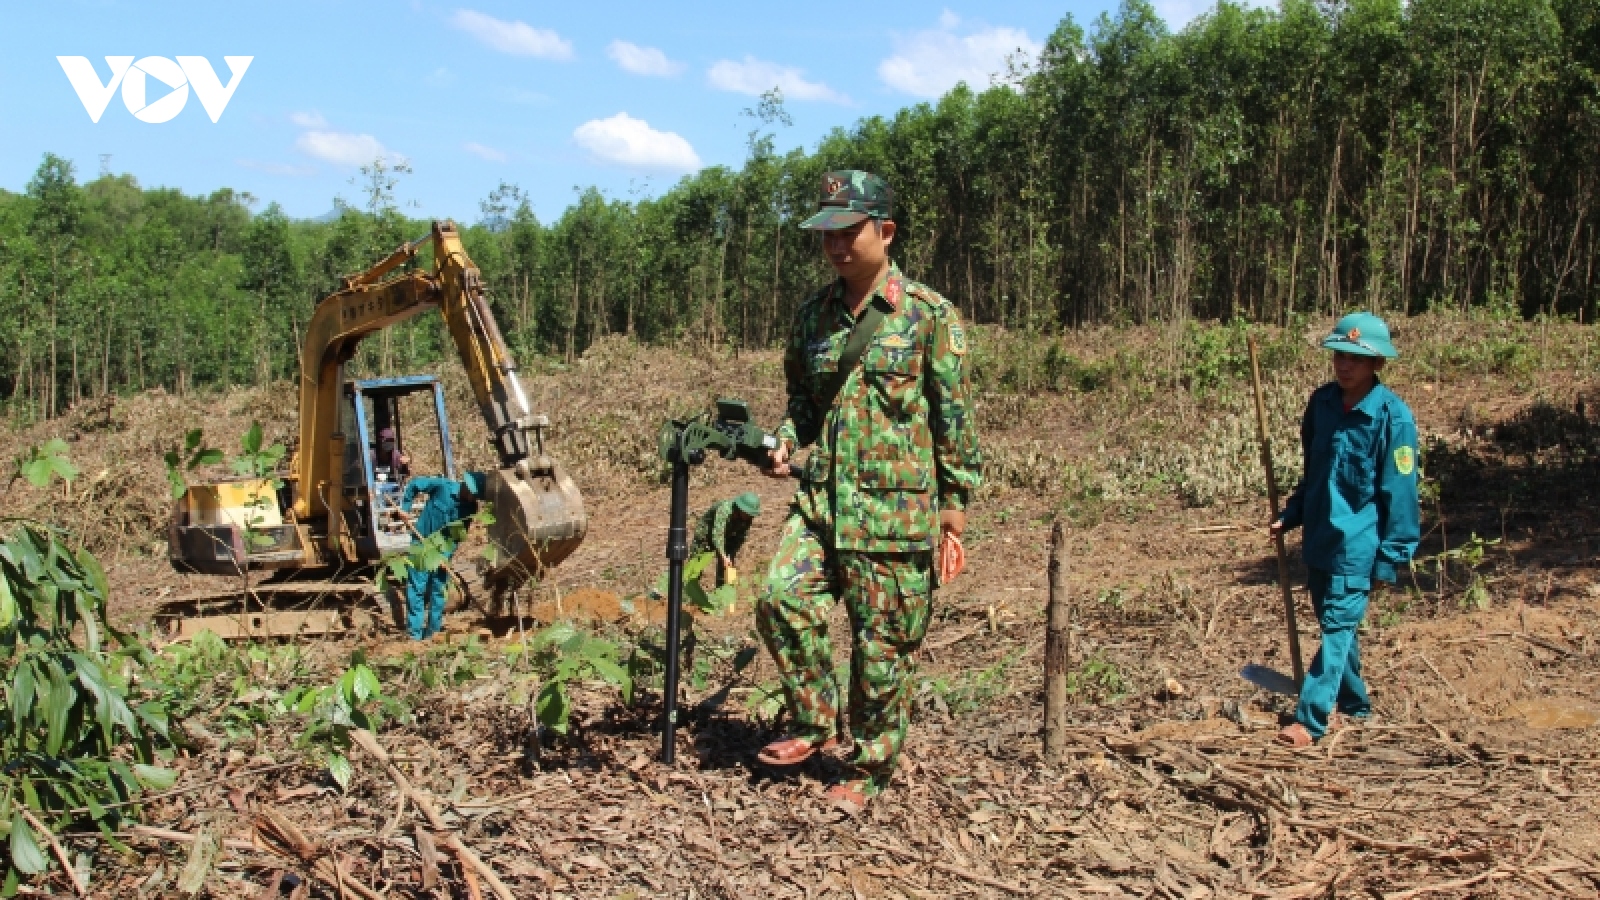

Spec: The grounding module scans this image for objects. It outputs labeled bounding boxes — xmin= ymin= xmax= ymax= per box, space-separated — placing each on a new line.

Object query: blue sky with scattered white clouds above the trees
xmin=0 ymin=0 xmax=1195 ymax=221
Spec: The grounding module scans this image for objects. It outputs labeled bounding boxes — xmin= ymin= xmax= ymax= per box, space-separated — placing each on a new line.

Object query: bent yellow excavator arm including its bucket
xmin=293 ymin=221 xmax=587 ymax=583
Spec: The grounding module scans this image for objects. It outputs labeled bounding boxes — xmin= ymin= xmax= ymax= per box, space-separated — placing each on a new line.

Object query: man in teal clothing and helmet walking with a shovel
xmin=1270 ymin=312 xmax=1421 ymax=746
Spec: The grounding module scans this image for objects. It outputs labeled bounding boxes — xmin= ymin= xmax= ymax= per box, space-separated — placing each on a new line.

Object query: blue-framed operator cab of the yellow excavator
xmin=339 ymin=375 xmax=456 ymax=560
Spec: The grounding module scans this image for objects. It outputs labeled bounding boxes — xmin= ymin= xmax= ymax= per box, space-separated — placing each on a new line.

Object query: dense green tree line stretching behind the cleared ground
xmin=0 ymin=0 xmax=1600 ymax=418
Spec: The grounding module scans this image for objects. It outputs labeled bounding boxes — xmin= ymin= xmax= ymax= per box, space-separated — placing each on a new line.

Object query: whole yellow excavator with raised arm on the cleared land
xmin=168 ymin=221 xmax=587 ymax=637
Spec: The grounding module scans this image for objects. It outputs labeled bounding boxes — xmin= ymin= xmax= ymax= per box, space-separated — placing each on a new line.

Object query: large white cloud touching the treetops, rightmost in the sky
xmin=878 ymin=10 xmax=1036 ymax=98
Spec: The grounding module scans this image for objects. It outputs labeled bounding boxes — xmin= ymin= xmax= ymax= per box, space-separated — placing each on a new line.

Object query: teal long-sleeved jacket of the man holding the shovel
xmin=1283 ymin=383 xmax=1421 ymax=583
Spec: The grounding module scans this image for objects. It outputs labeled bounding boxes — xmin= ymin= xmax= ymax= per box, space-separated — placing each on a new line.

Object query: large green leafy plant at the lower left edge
xmin=0 ymin=518 xmax=176 ymax=897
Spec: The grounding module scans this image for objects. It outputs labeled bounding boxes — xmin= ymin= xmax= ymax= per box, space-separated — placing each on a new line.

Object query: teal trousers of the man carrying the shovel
xmin=1294 ymin=569 xmax=1373 ymax=740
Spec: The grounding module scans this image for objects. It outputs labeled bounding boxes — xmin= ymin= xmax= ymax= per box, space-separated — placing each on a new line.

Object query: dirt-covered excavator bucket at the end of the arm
xmin=483 ymin=458 xmax=589 ymax=591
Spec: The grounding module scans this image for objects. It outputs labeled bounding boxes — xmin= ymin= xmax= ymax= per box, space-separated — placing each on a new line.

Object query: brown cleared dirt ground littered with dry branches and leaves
xmin=0 ymin=315 xmax=1600 ymax=900
